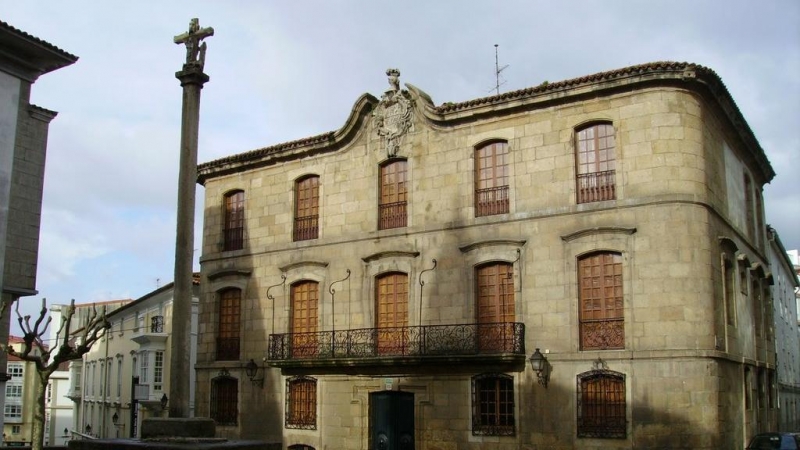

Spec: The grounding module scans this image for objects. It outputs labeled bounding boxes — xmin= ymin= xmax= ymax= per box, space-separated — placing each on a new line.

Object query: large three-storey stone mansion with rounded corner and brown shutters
xmin=196 ymin=62 xmax=776 ymax=450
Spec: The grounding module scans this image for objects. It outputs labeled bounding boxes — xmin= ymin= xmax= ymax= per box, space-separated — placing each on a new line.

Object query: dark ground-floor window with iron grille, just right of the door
xmin=472 ymin=373 xmax=516 ymax=436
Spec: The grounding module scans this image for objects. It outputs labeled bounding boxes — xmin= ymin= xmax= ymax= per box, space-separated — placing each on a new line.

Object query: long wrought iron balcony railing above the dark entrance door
xmin=268 ymin=322 xmax=525 ymax=367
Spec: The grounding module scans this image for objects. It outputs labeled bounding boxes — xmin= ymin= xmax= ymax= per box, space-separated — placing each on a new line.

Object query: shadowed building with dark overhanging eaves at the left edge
xmin=0 ymin=21 xmax=78 ymax=436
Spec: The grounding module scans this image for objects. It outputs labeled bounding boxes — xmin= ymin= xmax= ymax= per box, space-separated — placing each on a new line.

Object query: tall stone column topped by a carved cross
xmin=169 ymin=19 xmax=214 ymax=418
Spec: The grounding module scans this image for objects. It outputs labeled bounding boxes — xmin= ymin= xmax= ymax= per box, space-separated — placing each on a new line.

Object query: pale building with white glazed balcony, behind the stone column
xmin=72 ymin=279 xmax=199 ymax=438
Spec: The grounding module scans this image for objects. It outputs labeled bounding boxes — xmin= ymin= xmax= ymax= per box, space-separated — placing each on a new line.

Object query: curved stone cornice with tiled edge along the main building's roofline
xmin=198 ymin=61 xmax=775 ymax=184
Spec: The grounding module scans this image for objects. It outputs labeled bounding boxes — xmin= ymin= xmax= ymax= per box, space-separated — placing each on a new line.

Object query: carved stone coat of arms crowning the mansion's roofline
xmin=372 ymin=69 xmax=414 ymax=158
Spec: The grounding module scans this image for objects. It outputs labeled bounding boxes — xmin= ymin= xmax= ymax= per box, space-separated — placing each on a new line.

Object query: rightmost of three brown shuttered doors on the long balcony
xmin=475 ymin=262 xmax=516 ymax=353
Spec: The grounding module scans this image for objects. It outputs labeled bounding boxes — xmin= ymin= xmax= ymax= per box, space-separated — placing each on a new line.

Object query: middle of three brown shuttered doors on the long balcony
xmin=375 ymin=272 xmax=409 ymax=355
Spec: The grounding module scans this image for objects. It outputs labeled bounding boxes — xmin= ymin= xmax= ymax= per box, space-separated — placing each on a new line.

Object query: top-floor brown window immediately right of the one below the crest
xmin=475 ymin=141 xmax=510 ymax=217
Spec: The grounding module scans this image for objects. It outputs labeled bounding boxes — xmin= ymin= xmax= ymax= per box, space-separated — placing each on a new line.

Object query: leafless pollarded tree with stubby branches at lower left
xmin=0 ymin=299 xmax=109 ymax=450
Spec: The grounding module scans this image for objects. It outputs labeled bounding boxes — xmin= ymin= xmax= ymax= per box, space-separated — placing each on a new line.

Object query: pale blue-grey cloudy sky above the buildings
xmin=0 ymin=0 xmax=800 ymax=334
